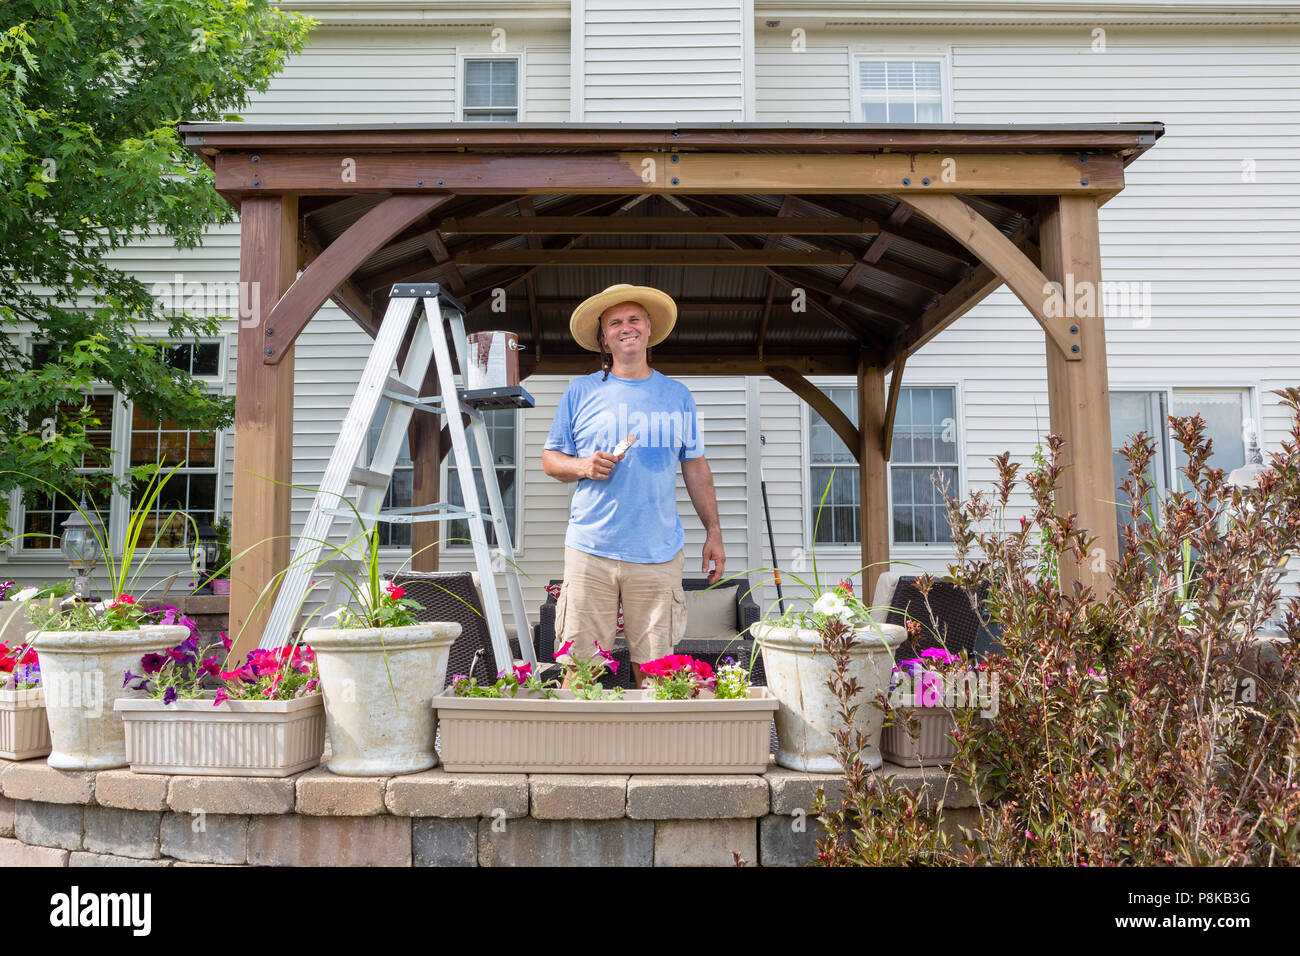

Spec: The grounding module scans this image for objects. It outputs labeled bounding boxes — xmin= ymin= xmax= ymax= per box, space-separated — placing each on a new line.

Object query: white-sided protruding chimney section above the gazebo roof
xmin=575 ymin=0 xmax=753 ymax=122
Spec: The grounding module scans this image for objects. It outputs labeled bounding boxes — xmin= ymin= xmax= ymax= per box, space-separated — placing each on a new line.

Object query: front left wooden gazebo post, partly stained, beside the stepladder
xmin=229 ymin=195 xmax=298 ymax=659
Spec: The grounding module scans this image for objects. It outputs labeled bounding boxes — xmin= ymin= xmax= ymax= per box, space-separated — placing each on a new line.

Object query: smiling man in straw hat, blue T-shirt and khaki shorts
xmin=542 ymin=285 xmax=727 ymax=687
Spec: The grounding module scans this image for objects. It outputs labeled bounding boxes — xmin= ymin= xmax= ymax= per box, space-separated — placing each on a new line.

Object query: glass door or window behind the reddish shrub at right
xmin=1110 ymin=389 xmax=1253 ymax=536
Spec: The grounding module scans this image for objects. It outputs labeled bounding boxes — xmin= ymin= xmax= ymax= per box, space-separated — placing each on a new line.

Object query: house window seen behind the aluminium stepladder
xmin=369 ymin=401 xmax=519 ymax=551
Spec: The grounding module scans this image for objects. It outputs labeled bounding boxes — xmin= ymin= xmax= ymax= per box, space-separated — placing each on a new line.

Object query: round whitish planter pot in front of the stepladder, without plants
xmin=303 ymin=622 xmax=460 ymax=777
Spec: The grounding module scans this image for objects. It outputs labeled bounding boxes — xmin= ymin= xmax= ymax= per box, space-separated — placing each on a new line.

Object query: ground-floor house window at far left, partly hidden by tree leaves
xmin=22 ymin=342 xmax=221 ymax=550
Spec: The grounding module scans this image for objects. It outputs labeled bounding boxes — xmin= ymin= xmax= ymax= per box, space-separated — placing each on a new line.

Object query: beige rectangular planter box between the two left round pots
xmin=113 ymin=693 xmax=325 ymax=777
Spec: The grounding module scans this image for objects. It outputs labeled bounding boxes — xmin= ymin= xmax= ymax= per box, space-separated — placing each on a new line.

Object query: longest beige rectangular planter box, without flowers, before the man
xmin=433 ymin=687 xmax=777 ymax=774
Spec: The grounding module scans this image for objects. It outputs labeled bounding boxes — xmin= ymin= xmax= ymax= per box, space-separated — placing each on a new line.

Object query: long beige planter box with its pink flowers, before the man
xmin=436 ymin=641 xmax=776 ymax=774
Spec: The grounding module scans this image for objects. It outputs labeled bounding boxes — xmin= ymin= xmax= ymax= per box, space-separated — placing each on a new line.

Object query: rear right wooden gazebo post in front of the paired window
xmin=858 ymin=350 xmax=889 ymax=604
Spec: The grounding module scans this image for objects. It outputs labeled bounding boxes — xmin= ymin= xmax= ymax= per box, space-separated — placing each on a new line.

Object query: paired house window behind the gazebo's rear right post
xmin=809 ymin=386 xmax=958 ymax=545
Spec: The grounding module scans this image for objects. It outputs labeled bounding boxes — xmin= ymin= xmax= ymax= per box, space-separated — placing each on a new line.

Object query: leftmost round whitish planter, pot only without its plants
xmin=35 ymin=624 xmax=190 ymax=770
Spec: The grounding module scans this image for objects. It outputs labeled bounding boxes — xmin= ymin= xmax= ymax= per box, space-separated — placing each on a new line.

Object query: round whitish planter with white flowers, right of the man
xmin=750 ymin=574 xmax=906 ymax=774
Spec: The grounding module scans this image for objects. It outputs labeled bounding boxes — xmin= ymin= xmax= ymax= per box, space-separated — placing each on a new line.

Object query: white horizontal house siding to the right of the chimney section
xmin=757 ymin=26 xmax=1300 ymax=598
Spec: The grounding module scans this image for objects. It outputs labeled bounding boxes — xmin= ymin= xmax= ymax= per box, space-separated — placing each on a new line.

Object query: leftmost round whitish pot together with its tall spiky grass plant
xmin=30 ymin=466 xmax=189 ymax=770
